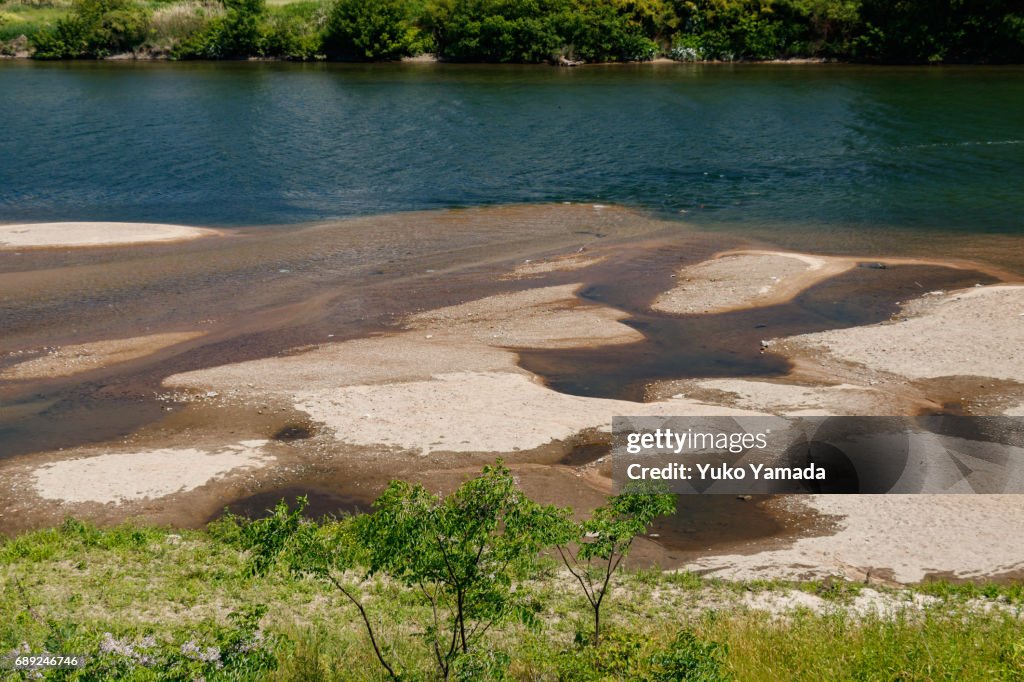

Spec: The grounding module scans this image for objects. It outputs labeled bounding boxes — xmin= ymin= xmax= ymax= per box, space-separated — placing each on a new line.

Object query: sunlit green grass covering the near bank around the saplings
xmin=0 ymin=521 xmax=1024 ymax=682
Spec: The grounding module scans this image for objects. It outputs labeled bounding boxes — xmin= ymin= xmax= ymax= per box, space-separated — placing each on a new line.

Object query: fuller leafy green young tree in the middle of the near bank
xmin=359 ymin=462 xmax=566 ymax=679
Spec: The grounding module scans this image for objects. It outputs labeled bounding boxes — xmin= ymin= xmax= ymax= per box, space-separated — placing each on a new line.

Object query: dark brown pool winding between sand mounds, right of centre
xmin=519 ymin=251 xmax=996 ymax=401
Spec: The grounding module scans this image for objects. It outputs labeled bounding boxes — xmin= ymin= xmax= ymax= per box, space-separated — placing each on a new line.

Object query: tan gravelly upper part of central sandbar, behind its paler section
xmin=165 ymin=285 xmax=639 ymax=394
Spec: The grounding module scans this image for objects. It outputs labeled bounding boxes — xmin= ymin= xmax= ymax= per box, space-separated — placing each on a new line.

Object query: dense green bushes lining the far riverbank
xmin=18 ymin=0 xmax=1024 ymax=63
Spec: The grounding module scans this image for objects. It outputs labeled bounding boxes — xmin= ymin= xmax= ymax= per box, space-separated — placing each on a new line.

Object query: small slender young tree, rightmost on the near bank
xmin=556 ymin=485 xmax=676 ymax=646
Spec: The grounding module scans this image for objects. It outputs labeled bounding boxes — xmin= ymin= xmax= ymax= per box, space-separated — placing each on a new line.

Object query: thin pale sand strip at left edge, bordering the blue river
xmin=0 ymin=222 xmax=218 ymax=249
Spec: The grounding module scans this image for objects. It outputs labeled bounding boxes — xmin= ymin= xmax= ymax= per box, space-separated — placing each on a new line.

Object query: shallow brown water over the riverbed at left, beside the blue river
xmin=0 ymin=201 xmax=679 ymax=460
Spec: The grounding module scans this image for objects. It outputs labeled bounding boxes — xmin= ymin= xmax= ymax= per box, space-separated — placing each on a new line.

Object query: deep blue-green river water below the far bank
xmin=0 ymin=61 xmax=1024 ymax=233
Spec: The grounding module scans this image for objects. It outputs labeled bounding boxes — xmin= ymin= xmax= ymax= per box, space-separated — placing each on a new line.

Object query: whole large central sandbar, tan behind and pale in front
xmin=165 ymin=285 xmax=753 ymax=453
